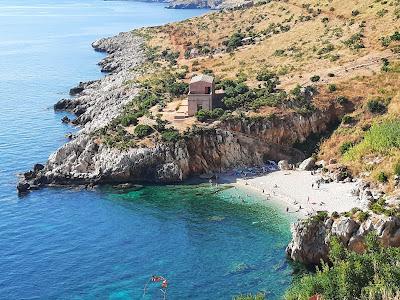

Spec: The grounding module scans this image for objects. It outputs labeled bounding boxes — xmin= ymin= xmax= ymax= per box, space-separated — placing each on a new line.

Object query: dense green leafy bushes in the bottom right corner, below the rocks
xmin=285 ymin=234 xmax=400 ymax=300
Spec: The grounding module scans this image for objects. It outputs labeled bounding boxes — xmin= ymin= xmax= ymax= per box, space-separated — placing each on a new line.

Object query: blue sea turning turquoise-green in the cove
xmin=0 ymin=0 xmax=292 ymax=299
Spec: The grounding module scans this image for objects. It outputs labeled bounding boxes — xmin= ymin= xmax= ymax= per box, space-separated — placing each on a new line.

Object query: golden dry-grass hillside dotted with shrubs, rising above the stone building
xmin=135 ymin=0 xmax=400 ymax=189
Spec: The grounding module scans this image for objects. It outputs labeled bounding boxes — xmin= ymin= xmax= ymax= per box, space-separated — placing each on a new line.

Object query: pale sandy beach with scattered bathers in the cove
xmin=221 ymin=171 xmax=360 ymax=216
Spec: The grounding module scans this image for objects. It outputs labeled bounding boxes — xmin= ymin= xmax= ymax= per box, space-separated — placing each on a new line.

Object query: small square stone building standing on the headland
xmin=188 ymin=74 xmax=215 ymax=116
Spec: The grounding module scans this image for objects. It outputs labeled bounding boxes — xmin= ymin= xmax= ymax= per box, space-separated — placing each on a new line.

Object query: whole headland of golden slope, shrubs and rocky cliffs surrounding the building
xmin=20 ymin=0 xmax=400 ymax=191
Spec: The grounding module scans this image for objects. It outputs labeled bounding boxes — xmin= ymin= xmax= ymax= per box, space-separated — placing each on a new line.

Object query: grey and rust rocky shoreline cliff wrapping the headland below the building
xmin=18 ymin=27 xmax=342 ymax=191
